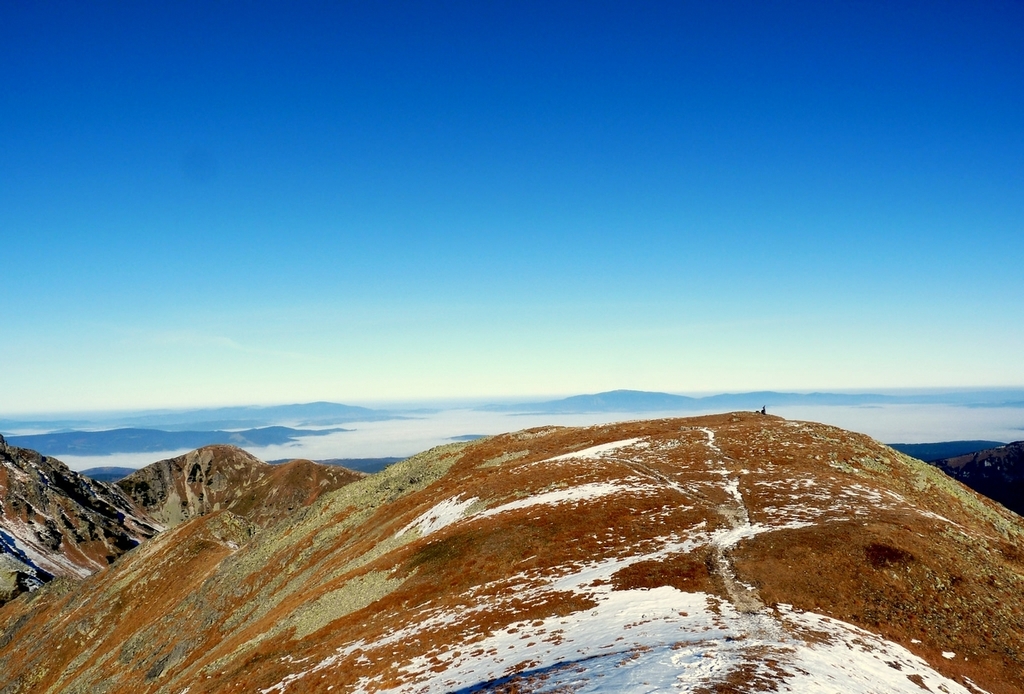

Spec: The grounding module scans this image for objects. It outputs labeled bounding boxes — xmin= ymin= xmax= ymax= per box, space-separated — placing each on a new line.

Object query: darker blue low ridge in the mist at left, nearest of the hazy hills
xmin=6 ymin=427 xmax=350 ymax=456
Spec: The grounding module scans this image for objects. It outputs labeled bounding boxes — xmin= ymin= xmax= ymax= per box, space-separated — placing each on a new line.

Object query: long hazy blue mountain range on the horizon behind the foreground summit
xmin=478 ymin=390 xmax=1024 ymax=415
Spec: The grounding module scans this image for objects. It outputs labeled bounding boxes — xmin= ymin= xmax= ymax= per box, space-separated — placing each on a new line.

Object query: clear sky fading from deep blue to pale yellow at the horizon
xmin=0 ymin=0 xmax=1024 ymax=413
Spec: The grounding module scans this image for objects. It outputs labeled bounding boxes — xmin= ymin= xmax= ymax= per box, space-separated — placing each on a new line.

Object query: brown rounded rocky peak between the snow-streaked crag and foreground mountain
xmin=117 ymin=445 xmax=365 ymax=526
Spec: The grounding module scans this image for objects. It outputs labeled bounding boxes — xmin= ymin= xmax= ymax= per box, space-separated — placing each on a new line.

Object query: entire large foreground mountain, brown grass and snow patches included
xmin=0 ymin=414 xmax=1024 ymax=694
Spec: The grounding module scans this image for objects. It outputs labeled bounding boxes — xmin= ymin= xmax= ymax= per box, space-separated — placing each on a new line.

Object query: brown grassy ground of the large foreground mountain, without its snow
xmin=0 ymin=414 xmax=1024 ymax=694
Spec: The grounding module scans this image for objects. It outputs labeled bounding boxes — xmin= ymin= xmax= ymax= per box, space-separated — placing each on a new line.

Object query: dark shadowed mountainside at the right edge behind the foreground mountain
xmin=934 ymin=441 xmax=1024 ymax=516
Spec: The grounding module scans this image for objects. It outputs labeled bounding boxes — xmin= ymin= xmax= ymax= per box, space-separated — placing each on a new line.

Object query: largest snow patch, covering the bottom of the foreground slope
xmin=368 ymin=566 xmax=969 ymax=694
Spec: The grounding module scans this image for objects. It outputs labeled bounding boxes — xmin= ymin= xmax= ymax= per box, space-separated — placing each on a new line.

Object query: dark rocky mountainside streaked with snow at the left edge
xmin=0 ymin=437 xmax=160 ymax=604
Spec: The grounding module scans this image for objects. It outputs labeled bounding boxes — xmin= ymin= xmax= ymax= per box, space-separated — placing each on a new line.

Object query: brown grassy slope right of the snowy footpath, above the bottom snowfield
xmin=720 ymin=419 xmax=1024 ymax=692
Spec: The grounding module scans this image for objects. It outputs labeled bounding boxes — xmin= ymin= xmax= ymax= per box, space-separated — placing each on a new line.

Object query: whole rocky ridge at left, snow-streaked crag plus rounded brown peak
xmin=0 ymin=437 xmax=365 ymax=604
